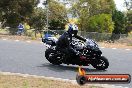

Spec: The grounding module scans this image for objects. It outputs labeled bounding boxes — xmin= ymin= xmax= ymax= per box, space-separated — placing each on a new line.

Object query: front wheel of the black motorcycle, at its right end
xmin=91 ymin=56 xmax=109 ymax=70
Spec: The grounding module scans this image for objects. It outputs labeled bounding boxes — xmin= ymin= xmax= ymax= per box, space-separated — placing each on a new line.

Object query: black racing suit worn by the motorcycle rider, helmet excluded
xmin=56 ymin=32 xmax=86 ymax=62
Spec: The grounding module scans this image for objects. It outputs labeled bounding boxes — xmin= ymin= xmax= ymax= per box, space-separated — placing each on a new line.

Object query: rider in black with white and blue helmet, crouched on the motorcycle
xmin=56 ymin=24 xmax=86 ymax=60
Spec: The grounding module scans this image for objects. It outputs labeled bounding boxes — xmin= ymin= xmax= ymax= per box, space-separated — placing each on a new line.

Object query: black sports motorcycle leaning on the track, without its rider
xmin=45 ymin=37 xmax=109 ymax=70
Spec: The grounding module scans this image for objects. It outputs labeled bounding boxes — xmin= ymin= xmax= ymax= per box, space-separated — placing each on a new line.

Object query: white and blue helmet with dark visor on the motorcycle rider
xmin=67 ymin=24 xmax=78 ymax=36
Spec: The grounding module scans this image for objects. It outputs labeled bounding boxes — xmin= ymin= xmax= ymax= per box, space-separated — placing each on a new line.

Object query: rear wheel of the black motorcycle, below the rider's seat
xmin=45 ymin=48 xmax=62 ymax=65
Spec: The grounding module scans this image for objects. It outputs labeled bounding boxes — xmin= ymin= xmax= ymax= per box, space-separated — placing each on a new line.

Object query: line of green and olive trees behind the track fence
xmin=0 ymin=0 xmax=132 ymax=34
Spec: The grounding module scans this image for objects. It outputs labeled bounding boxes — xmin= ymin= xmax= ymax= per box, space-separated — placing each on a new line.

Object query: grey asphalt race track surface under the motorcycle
xmin=0 ymin=39 xmax=132 ymax=88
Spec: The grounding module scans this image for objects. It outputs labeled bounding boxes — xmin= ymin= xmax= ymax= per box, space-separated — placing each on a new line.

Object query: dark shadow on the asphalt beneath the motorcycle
xmin=38 ymin=63 xmax=106 ymax=73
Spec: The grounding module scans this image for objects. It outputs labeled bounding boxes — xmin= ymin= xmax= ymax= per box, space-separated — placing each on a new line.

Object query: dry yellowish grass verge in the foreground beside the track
xmin=0 ymin=74 xmax=103 ymax=88
